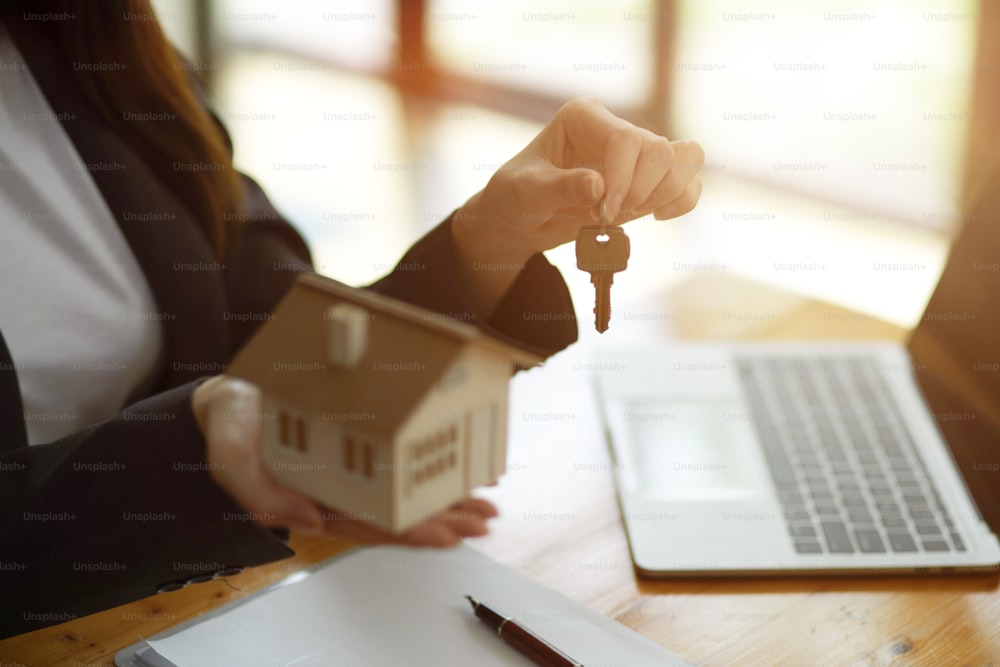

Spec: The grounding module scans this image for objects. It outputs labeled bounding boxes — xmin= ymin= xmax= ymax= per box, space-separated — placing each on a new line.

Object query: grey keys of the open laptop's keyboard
xmin=737 ymin=357 xmax=965 ymax=554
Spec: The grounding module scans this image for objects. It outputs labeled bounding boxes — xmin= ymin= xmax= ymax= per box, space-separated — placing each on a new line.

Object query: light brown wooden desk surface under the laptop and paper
xmin=0 ymin=276 xmax=1000 ymax=667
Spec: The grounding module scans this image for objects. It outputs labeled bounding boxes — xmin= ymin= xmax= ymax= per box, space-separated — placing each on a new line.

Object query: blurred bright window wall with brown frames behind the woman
xmin=148 ymin=0 xmax=1000 ymax=328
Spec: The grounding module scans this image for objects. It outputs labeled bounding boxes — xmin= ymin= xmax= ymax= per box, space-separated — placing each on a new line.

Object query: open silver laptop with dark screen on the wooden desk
xmin=595 ymin=188 xmax=1000 ymax=577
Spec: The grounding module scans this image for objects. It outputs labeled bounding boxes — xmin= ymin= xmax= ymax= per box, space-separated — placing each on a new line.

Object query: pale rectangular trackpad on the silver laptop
xmin=622 ymin=401 xmax=770 ymax=501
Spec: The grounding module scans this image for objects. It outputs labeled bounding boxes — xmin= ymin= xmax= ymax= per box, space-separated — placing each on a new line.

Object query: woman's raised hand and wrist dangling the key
xmin=452 ymin=98 xmax=705 ymax=314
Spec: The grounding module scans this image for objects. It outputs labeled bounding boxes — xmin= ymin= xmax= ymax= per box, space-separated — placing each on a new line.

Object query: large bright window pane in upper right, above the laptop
xmin=669 ymin=0 xmax=978 ymax=227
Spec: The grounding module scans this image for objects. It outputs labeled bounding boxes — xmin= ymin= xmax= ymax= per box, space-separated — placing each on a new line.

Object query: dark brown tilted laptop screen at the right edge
xmin=909 ymin=178 xmax=1000 ymax=534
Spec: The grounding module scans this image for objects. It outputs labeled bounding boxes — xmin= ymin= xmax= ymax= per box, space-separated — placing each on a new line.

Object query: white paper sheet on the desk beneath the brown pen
xmin=143 ymin=546 xmax=689 ymax=667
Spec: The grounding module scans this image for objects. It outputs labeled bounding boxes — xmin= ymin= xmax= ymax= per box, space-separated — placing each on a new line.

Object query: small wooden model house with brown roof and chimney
xmin=226 ymin=274 xmax=541 ymax=532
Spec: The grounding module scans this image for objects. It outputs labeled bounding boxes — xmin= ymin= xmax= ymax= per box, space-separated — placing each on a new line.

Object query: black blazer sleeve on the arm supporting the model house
xmin=0 ymin=383 xmax=293 ymax=637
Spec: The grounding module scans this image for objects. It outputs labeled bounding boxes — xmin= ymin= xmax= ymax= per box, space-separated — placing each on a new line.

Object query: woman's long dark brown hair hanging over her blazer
xmin=2 ymin=0 xmax=243 ymax=257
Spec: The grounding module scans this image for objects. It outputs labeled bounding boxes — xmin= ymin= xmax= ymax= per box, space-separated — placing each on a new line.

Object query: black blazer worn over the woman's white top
xmin=0 ymin=22 xmax=576 ymax=637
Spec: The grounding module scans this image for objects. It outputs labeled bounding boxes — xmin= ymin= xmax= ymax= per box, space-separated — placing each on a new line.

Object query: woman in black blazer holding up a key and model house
xmin=0 ymin=0 xmax=703 ymax=636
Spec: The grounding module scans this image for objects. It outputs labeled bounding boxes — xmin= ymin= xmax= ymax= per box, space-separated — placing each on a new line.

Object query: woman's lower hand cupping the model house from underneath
xmin=191 ymin=375 xmax=497 ymax=547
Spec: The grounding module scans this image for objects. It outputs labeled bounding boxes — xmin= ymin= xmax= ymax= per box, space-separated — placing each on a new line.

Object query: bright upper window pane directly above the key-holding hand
xmin=425 ymin=0 xmax=656 ymax=108
